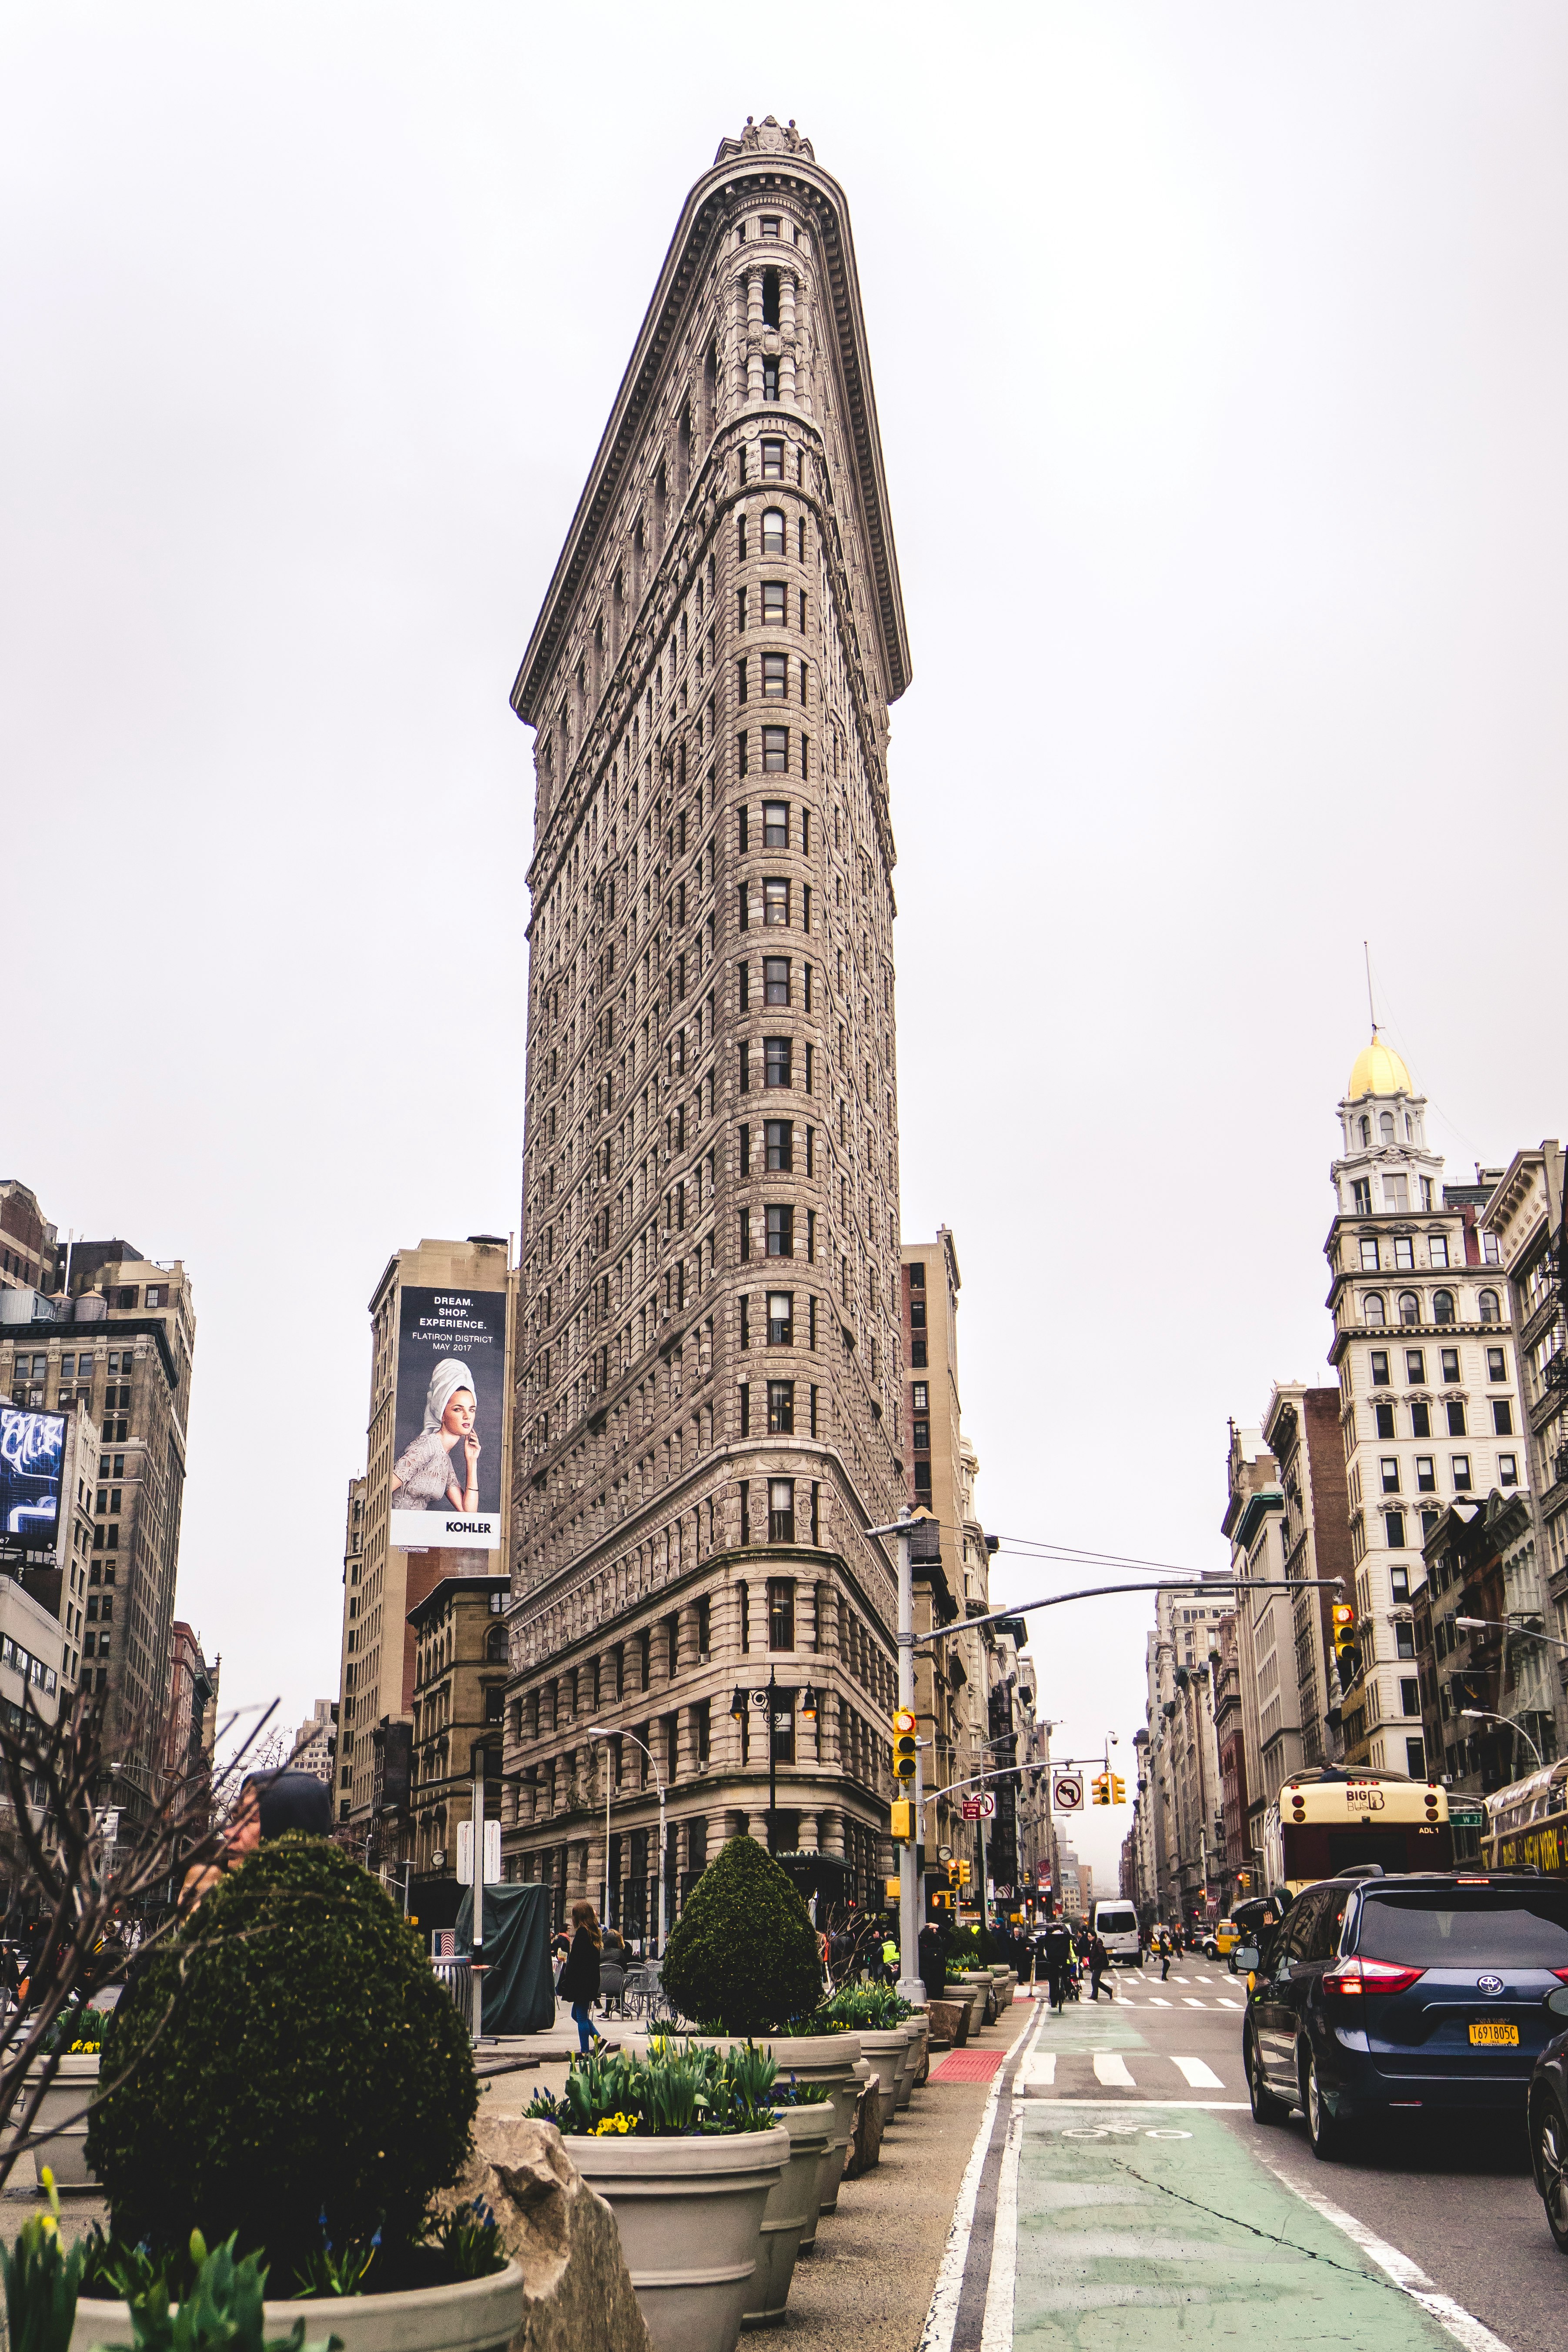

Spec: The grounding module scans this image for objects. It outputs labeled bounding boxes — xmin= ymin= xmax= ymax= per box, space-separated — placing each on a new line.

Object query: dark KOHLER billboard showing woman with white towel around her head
xmin=390 ymin=1289 xmax=505 ymax=1552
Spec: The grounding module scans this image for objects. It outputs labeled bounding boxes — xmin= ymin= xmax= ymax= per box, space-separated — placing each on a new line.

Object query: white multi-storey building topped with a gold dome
xmin=1324 ymin=1028 xmax=1545 ymax=1785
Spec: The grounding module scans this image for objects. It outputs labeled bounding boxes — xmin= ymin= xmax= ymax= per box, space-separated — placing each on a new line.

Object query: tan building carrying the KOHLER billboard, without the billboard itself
xmin=336 ymin=1235 xmax=515 ymax=1870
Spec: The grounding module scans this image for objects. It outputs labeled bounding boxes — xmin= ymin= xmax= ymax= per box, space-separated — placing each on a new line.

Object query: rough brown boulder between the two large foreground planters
xmin=437 ymin=2115 xmax=654 ymax=2352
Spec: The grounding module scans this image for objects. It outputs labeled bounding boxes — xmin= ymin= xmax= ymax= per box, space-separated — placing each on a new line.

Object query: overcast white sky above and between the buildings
xmin=0 ymin=0 xmax=1568 ymax=1865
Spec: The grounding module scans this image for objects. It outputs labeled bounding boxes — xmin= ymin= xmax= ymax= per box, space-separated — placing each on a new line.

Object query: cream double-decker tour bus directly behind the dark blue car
xmin=1262 ymin=1764 xmax=1453 ymax=1896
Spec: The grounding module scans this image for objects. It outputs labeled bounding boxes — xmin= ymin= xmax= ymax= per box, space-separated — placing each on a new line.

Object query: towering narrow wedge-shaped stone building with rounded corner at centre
xmin=505 ymin=117 xmax=910 ymax=1921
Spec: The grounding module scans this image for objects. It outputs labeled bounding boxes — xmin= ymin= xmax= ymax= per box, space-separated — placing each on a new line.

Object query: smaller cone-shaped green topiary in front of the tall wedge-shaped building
xmin=663 ymin=1837 xmax=823 ymax=2035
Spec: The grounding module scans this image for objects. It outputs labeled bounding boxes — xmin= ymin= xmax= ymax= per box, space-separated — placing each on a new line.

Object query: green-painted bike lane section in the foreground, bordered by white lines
xmin=997 ymin=2098 xmax=1495 ymax=2352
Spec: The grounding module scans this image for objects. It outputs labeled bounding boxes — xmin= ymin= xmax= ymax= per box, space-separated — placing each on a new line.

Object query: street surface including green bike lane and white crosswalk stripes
xmin=1013 ymin=1959 xmax=1568 ymax=2352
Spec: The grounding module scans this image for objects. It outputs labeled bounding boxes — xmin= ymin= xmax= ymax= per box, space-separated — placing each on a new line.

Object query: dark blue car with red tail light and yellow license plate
xmin=1237 ymin=1872 xmax=1568 ymax=2157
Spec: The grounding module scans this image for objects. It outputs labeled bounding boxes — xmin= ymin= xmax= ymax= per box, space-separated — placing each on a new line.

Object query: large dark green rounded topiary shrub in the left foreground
xmin=87 ymin=1837 xmax=480 ymax=2293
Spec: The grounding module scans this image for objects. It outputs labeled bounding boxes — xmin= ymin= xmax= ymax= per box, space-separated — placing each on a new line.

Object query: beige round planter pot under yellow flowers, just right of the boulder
xmin=567 ymin=2128 xmax=799 ymax=2352
